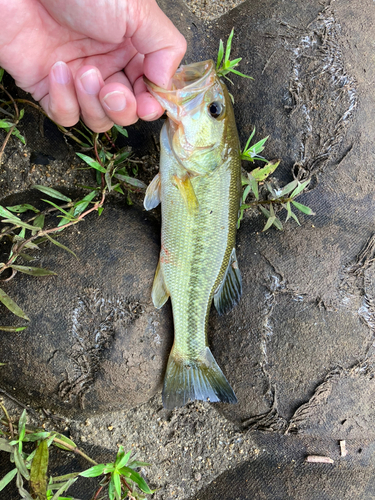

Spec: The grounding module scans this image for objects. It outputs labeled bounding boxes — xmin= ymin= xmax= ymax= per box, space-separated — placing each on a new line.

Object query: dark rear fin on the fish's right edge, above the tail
xmin=214 ymin=248 xmax=242 ymax=314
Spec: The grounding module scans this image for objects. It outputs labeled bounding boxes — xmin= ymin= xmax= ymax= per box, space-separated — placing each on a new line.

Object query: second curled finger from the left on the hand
xmin=75 ymin=66 xmax=113 ymax=132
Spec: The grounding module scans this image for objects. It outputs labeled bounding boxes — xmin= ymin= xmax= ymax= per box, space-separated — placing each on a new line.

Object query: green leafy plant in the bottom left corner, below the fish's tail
xmin=0 ymin=404 xmax=154 ymax=500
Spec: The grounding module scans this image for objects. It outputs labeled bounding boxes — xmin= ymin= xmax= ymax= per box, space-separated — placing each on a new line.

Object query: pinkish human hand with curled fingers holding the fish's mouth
xmin=0 ymin=0 xmax=186 ymax=132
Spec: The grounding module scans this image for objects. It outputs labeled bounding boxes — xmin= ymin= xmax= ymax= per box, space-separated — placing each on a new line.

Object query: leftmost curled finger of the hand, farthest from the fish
xmin=40 ymin=61 xmax=79 ymax=127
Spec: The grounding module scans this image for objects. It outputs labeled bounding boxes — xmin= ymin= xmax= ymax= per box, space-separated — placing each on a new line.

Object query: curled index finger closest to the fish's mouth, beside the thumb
xmin=125 ymin=53 xmax=164 ymax=121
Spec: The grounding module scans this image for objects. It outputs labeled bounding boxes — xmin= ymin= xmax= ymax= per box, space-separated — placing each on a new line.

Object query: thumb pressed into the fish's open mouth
xmin=131 ymin=0 xmax=186 ymax=88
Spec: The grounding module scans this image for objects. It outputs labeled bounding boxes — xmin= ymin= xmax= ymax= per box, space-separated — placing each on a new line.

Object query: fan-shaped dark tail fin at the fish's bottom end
xmin=163 ymin=347 xmax=237 ymax=410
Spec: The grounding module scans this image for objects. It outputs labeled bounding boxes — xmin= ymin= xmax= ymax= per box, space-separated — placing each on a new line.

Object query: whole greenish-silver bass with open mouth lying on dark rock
xmin=144 ymin=60 xmax=242 ymax=409
